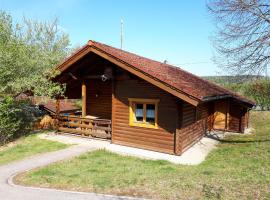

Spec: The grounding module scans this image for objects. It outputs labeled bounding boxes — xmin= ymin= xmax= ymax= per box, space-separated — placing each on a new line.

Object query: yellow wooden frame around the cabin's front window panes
xmin=128 ymin=98 xmax=159 ymax=129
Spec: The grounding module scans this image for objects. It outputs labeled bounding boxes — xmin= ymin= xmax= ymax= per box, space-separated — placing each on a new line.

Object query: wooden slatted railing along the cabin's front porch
xmin=58 ymin=115 xmax=112 ymax=139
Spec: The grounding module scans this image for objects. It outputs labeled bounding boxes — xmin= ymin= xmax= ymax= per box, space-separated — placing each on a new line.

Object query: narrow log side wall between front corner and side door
xmin=175 ymin=102 xmax=210 ymax=155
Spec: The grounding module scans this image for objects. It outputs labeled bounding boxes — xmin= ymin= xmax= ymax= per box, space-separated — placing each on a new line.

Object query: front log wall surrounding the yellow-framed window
xmin=112 ymin=70 xmax=178 ymax=154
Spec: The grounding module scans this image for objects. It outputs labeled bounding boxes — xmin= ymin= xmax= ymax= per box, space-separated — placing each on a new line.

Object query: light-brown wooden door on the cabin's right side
xmin=214 ymin=101 xmax=227 ymax=130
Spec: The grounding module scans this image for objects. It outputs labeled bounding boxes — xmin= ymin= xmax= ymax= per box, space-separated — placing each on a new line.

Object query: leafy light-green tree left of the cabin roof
xmin=0 ymin=11 xmax=70 ymax=97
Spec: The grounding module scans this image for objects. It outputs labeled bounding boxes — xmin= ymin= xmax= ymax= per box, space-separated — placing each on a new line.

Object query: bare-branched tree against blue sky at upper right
xmin=207 ymin=0 xmax=270 ymax=74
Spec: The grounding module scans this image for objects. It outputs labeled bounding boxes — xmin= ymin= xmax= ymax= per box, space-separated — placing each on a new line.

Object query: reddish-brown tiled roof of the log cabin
xmin=57 ymin=40 xmax=255 ymax=105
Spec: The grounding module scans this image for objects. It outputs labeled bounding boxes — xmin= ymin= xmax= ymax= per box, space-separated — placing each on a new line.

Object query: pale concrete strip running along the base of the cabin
xmin=40 ymin=133 xmax=223 ymax=165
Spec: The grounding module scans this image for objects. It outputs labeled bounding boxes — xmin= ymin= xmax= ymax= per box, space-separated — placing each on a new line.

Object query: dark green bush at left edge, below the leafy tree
xmin=0 ymin=97 xmax=40 ymax=145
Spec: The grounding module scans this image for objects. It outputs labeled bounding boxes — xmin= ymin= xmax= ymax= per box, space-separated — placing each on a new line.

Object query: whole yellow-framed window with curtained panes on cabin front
xmin=128 ymin=98 xmax=159 ymax=128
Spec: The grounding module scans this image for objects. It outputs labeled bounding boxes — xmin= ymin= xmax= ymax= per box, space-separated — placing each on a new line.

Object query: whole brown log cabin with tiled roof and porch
xmin=56 ymin=41 xmax=254 ymax=155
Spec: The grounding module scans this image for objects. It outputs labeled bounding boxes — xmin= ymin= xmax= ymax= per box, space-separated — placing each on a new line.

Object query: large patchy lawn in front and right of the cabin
xmin=17 ymin=112 xmax=270 ymax=200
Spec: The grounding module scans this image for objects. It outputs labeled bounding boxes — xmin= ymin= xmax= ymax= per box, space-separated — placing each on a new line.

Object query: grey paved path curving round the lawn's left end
xmin=0 ymin=144 xmax=141 ymax=200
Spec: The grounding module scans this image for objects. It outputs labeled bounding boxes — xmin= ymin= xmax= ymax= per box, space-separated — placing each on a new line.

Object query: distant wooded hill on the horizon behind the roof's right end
xmin=202 ymin=75 xmax=264 ymax=85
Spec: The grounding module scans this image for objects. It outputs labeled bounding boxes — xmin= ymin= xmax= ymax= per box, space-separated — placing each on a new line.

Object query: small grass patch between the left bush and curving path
xmin=0 ymin=135 xmax=68 ymax=165
